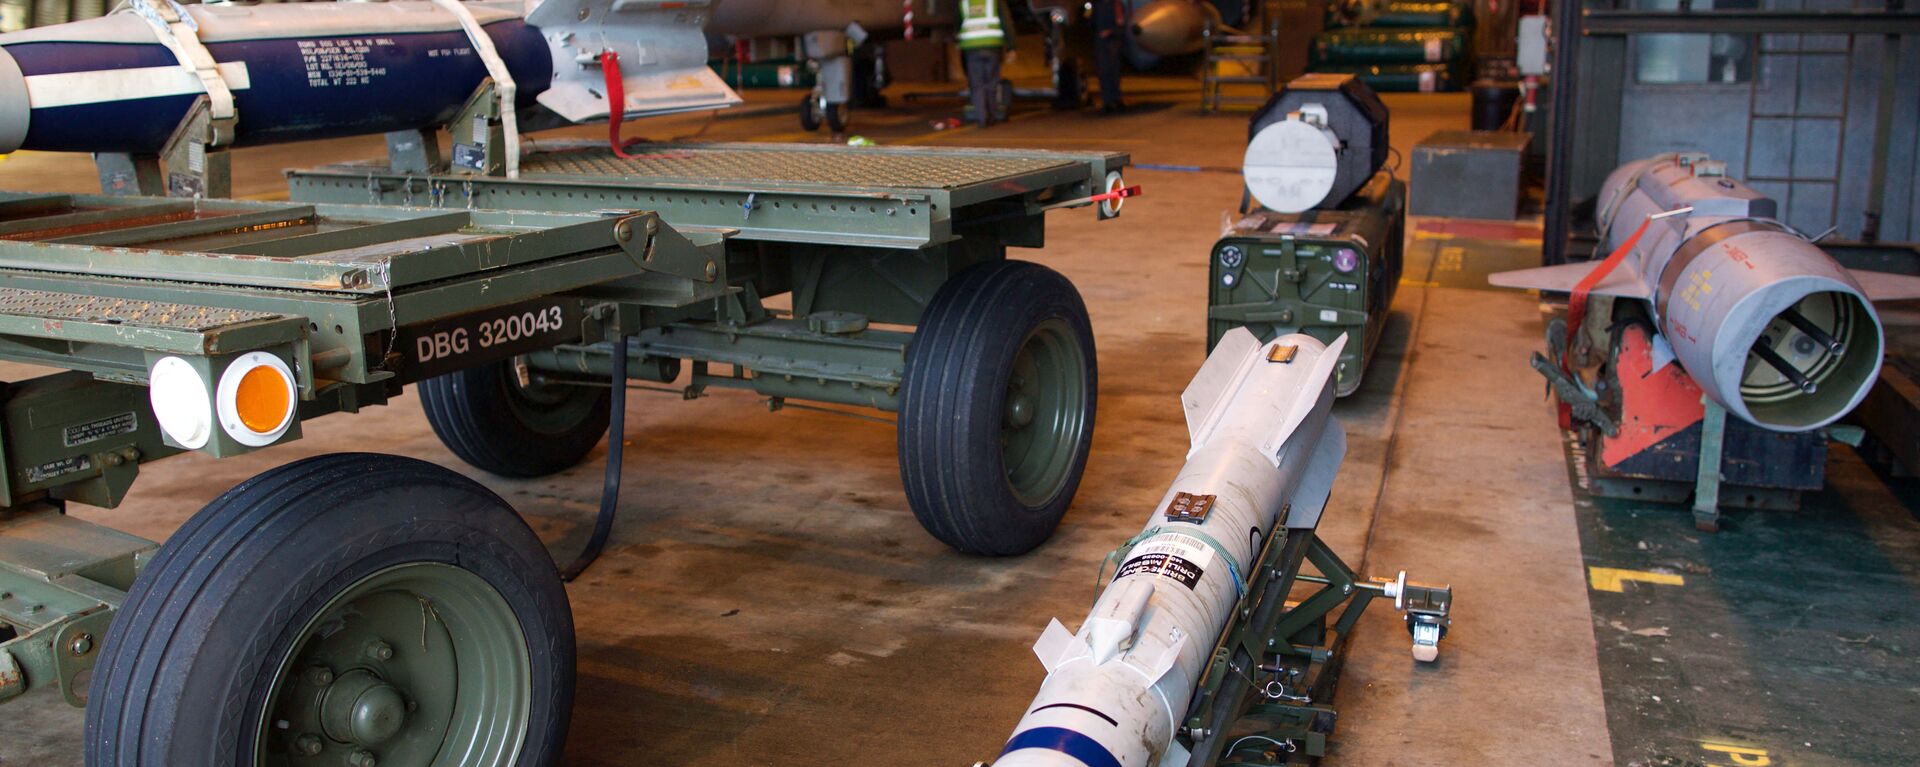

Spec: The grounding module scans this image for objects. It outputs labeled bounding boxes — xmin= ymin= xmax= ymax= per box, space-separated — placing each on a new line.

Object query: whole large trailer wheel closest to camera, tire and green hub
xmin=86 ymin=454 xmax=574 ymax=767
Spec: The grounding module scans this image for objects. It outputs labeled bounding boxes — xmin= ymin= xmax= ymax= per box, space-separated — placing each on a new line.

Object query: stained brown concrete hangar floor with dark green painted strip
xmin=0 ymin=79 xmax=1920 ymax=767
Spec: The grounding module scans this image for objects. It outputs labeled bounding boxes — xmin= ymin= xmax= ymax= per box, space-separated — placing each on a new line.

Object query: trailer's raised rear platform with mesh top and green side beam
xmin=288 ymin=142 xmax=1127 ymax=248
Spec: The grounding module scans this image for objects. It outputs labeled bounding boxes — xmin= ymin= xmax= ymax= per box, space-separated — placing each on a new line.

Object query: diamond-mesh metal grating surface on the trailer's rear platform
xmin=520 ymin=144 xmax=1077 ymax=188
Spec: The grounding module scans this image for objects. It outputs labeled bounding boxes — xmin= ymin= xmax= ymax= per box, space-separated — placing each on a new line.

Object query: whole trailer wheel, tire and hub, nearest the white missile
xmin=899 ymin=261 xmax=1098 ymax=556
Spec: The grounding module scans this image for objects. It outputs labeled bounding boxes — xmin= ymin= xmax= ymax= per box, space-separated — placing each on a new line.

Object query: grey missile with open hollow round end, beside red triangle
xmin=1490 ymin=152 xmax=1920 ymax=433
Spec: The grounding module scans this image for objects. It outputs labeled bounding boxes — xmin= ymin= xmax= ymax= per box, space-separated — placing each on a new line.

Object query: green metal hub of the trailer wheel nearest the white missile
xmin=1000 ymin=319 xmax=1087 ymax=507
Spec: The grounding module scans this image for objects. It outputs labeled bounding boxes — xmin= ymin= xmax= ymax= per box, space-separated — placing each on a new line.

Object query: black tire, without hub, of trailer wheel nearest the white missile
xmin=899 ymin=261 xmax=1098 ymax=556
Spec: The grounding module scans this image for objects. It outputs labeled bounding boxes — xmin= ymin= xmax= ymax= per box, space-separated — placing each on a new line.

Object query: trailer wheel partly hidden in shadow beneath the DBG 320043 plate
xmin=420 ymin=359 xmax=609 ymax=479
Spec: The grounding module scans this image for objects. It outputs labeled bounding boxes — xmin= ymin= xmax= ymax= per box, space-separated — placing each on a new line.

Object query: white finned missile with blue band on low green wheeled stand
xmin=993 ymin=329 xmax=1346 ymax=767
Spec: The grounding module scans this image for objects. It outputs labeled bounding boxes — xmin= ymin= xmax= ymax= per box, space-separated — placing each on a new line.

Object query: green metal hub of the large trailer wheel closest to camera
xmin=253 ymin=563 xmax=532 ymax=767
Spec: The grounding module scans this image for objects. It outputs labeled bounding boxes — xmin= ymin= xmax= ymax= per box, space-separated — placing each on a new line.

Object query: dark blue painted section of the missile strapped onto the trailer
xmin=6 ymin=19 xmax=553 ymax=152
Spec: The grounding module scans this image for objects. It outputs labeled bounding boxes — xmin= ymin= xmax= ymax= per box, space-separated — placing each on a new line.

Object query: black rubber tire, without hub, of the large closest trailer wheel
xmin=86 ymin=454 xmax=574 ymax=767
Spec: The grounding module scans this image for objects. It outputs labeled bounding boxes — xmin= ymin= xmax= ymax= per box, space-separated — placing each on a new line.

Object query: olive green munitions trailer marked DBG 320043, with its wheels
xmin=0 ymin=144 xmax=1127 ymax=765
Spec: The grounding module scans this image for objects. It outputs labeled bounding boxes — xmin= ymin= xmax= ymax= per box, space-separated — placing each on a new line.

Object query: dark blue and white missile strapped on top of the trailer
xmin=0 ymin=0 xmax=739 ymax=156
